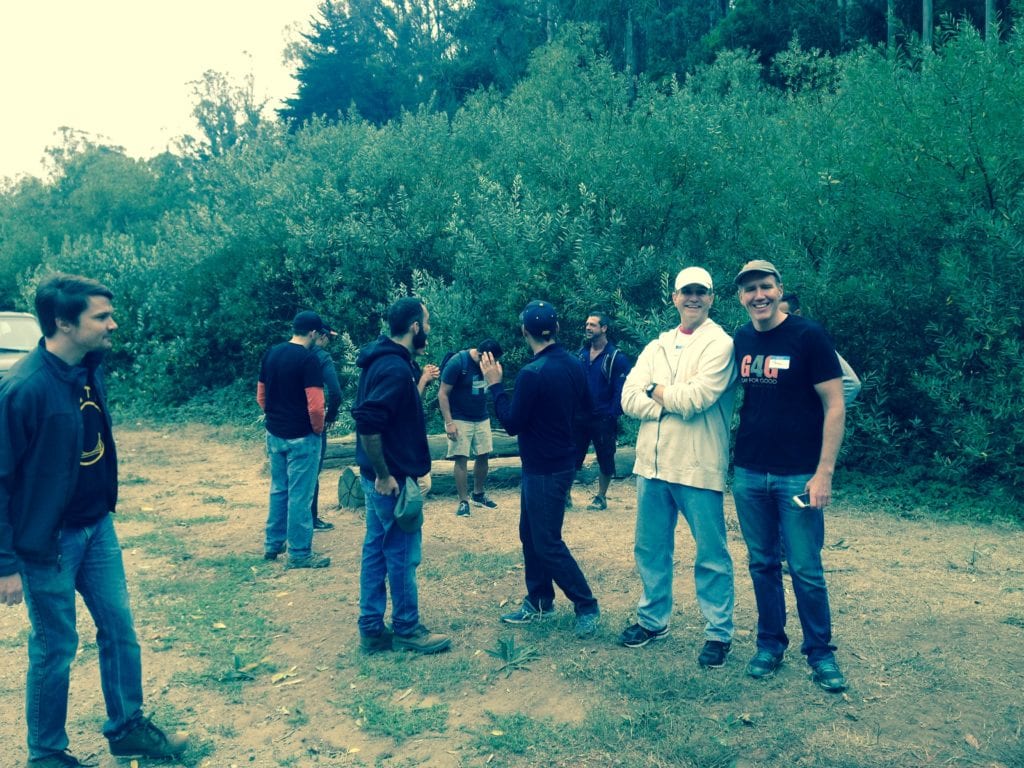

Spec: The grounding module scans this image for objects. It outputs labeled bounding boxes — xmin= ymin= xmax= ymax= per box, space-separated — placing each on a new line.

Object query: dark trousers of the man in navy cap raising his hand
xmin=519 ymin=469 xmax=597 ymax=615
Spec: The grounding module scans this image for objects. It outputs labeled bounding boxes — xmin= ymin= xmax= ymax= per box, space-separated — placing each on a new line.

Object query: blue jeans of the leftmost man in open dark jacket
xmin=22 ymin=515 xmax=142 ymax=759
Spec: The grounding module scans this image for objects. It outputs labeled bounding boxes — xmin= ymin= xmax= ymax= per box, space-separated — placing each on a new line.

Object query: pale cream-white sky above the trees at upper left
xmin=0 ymin=0 xmax=319 ymax=178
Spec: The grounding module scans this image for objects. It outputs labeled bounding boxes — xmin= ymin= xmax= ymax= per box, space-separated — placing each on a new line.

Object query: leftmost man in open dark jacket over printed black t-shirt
xmin=0 ymin=274 xmax=187 ymax=768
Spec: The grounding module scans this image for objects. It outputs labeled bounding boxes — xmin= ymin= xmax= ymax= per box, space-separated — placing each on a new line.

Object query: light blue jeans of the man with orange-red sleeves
xmin=264 ymin=432 xmax=321 ymax=558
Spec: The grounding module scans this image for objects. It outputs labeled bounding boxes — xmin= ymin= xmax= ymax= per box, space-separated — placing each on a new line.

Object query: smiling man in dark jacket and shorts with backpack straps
xmin=566 ymin=311 xmax=630 ymax=510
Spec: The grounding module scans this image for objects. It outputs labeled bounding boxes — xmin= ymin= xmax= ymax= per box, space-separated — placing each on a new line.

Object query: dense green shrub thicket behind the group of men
xmin=0 ymin=25 xmax=1024 ymax=497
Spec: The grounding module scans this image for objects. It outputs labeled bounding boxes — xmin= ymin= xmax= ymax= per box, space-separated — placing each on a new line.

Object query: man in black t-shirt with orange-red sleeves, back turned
xmin=256 ymin=309 xmax=331 ymax=568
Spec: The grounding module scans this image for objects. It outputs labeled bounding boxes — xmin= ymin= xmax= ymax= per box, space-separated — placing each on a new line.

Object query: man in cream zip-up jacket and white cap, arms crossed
xmin=621 ymin=266 xmax=736 ymax=669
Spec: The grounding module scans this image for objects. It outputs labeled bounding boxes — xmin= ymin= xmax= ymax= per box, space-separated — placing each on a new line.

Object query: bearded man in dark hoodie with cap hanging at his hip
xmin=352 ymin=296 xmax=452 ymax=653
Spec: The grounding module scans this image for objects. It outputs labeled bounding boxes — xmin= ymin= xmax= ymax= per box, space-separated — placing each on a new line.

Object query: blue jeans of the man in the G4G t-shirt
xmin=732 ymin=467 xmax=836 ymax=665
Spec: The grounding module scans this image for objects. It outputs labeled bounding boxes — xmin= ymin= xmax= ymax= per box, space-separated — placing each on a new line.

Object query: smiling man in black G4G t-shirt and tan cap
xmin=732 ymin=259 xmax=846 ymax=692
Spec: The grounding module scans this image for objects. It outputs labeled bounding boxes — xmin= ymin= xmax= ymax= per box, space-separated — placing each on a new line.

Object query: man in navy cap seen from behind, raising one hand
xmin=480 ymin=301 xmax=600 ymax=638
